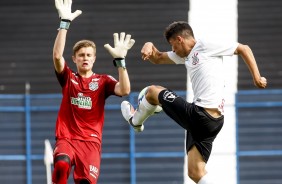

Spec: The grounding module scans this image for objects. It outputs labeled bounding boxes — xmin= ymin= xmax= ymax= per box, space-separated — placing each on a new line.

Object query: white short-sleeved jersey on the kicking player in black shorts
xmin=167 ymin=40 xmax=239 ymax=114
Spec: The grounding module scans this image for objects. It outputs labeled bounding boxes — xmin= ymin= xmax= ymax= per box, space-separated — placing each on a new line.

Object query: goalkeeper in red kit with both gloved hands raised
xmin=52 ymin=0 xmax=135 ymax=184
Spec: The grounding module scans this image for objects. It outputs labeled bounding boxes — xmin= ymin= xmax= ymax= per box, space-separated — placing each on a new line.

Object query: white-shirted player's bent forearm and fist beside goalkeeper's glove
xmin=141 ymin=42 xmax=175 ymax=64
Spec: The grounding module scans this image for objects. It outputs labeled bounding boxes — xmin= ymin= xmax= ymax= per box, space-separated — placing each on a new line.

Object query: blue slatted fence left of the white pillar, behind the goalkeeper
xmin=0 ymin=92 xmax=185 ymax=184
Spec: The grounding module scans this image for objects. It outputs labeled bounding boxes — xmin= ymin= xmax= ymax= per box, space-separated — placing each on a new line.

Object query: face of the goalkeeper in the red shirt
xmin=72 ymin=47 xmax=96 ymax=73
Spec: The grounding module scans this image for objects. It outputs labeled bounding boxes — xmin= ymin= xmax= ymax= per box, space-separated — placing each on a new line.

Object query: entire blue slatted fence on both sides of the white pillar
xmin=0 ymin=90 xmax=282 ymax=184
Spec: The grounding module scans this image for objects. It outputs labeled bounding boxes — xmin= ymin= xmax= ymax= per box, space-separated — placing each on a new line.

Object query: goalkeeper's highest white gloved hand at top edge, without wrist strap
xmin=55 ymin=0 xmax=82 ymax=21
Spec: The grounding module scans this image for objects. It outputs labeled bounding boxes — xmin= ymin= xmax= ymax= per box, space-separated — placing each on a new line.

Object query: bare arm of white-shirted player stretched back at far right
xmin=235 ymin=44 xmax=267 ymax=88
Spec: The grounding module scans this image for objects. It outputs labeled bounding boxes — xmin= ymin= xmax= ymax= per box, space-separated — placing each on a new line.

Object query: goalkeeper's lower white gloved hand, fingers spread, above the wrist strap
xmin=104 ymin=32 xmax=135 ymax=58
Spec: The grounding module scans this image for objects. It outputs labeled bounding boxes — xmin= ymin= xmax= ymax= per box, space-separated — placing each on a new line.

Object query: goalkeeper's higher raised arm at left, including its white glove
xmin=53 ymin=0 xmax=82 ymax=73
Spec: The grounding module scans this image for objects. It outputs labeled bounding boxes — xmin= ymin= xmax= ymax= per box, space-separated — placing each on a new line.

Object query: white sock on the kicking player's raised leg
xmin=132 ymin=96 xmax=157 ymax=125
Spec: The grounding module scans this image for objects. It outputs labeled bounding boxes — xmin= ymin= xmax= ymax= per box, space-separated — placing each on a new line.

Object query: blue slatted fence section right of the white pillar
xmin=236 ymin=90 xmax=282 ymax=184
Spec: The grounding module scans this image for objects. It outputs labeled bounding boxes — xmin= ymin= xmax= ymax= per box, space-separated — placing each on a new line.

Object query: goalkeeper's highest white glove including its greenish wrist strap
xmin=55 ymin=0 xmax=82 ymax=29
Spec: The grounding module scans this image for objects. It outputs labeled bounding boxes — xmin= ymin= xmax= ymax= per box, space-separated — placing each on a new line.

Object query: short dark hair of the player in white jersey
xmin=164 ymin=21 xmax=194 ymax=41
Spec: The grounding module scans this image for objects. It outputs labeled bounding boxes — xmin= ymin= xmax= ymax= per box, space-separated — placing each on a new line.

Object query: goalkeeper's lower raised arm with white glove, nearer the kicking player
xmin=104 ymin=32 xmax=135 ymax=96
